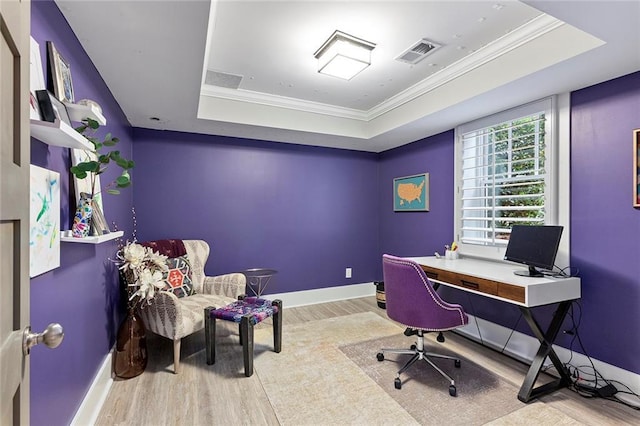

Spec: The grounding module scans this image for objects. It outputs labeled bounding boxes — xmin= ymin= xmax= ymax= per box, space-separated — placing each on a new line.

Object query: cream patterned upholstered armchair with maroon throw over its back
xmin=139 ymin=240 xmax=246 ymax=374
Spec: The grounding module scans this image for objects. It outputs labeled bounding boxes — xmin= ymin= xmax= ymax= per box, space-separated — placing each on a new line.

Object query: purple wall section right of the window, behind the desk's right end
xmin=571 ymin=72 xmax=640 ymax=373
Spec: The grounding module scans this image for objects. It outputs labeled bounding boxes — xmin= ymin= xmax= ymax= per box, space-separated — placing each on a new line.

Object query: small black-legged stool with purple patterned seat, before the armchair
xmin=204 ymin=297 xmax=282 ymax=377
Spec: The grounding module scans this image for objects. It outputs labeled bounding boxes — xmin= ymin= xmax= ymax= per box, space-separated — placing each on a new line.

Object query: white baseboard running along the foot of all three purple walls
xmin=71 ymin=282 xmax=640 ymax=420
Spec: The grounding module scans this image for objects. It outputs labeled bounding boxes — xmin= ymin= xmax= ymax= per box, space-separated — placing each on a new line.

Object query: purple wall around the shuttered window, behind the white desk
xmin=379 ymin=72 xmax=640 ymax=373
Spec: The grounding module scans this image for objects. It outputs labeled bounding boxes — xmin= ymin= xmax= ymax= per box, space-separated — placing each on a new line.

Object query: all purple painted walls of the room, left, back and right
xmin=26 ymin=1 xmax=640 ymax=425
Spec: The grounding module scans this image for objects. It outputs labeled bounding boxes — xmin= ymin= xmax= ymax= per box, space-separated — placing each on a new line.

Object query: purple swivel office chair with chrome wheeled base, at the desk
xmin=377 ymin=254 xmax=469 ymax=396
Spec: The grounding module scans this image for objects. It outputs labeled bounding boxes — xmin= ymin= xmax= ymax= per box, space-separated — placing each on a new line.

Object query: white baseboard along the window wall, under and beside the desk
xmin=456 ymin=315 xmax=640 ymax=404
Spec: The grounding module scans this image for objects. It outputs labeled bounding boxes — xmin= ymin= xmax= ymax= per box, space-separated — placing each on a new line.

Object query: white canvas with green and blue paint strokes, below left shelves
xmin=29 ymin=165 xmax=60 ymax=277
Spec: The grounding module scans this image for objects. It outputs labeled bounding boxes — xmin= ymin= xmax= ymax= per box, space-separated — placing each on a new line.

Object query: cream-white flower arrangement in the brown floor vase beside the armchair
xmin=115 ymin=241 xmax=168 ymax=308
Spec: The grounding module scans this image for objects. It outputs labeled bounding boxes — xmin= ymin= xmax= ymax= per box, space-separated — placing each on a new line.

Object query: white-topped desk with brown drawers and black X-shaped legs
xmin=409 ymin=256 xmax=580 ymax=402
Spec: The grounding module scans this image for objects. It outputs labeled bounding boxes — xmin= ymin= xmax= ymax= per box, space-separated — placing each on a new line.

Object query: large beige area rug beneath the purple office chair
xmin=254 ymin=312 xmax=576 ymax=426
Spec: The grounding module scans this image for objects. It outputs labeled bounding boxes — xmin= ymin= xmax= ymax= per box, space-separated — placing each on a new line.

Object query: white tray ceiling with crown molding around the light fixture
xmin=56 ymin=0 xmax=640 ymax=152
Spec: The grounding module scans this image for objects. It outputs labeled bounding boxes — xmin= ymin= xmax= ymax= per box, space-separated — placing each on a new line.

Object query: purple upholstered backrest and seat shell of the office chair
xmin=382 ymin=254 xmax=468 ymax=331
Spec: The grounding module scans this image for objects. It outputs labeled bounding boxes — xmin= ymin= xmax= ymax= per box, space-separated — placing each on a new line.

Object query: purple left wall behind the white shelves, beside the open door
xmin=30 ymin=1 xmax=135 ymax=425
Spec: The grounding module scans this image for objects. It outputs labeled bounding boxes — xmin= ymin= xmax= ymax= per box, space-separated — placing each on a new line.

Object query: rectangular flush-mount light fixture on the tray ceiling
xmin=313 ymin=30 xmax=376 ymax=80
